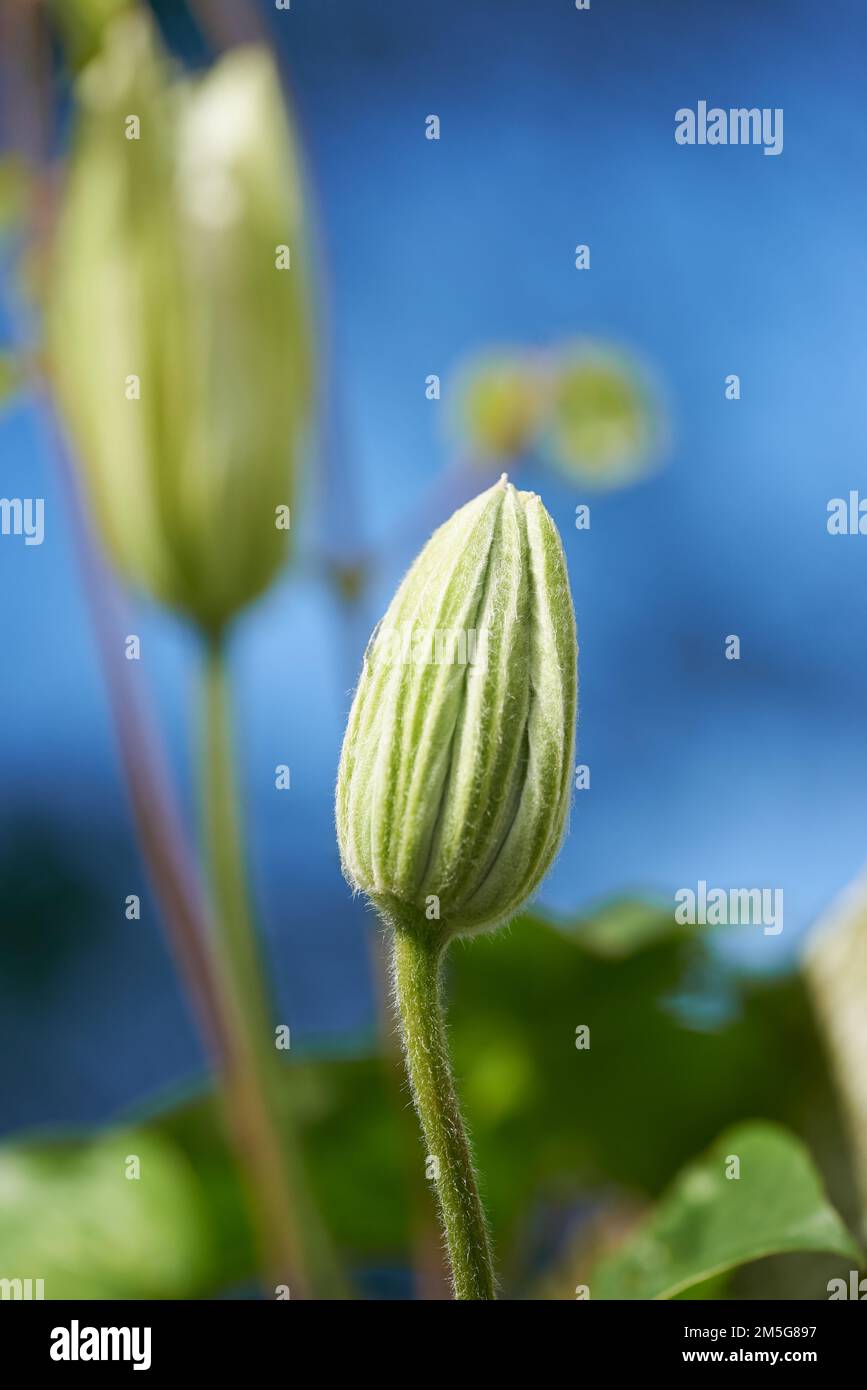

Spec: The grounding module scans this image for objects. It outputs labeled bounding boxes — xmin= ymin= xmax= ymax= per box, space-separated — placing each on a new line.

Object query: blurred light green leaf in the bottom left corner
xmin=0 ymin=1130 xmax=211 ymax=1300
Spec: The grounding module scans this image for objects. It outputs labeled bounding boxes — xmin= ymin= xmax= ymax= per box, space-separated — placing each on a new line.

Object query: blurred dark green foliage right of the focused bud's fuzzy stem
xmin=447 ymin=909 xmax=827 ymax=1245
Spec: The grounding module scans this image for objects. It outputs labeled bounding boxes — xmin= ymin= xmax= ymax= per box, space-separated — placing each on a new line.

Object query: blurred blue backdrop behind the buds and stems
xmin=0 ymin=0 xmax=867 ymax=1129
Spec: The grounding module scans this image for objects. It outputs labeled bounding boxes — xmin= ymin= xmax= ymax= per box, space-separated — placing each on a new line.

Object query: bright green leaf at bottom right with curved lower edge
xmin=589 ymin=1123 xmax=861 ymax=1298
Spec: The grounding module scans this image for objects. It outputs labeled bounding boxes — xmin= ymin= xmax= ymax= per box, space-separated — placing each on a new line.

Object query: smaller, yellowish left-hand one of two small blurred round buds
xmin=459 ymin=354 xmax=545 ymax=460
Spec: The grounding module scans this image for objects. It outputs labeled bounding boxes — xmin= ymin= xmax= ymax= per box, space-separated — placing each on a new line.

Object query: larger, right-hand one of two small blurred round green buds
xmin=545 ymin=345 xmax=659 ymax=488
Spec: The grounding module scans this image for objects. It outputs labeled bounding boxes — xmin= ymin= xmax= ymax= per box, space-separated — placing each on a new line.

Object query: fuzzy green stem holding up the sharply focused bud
xmin=395 ymin=927 xmax=496 ymax=1300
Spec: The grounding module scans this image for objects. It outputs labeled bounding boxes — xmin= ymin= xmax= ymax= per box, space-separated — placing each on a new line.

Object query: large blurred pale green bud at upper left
xmin=49 ymin=13 xmax=311 ymax=631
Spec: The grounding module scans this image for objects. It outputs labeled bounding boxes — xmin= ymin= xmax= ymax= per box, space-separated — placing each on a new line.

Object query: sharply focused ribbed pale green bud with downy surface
xmin=336 ymin=475 xmax=577 ymax=940
